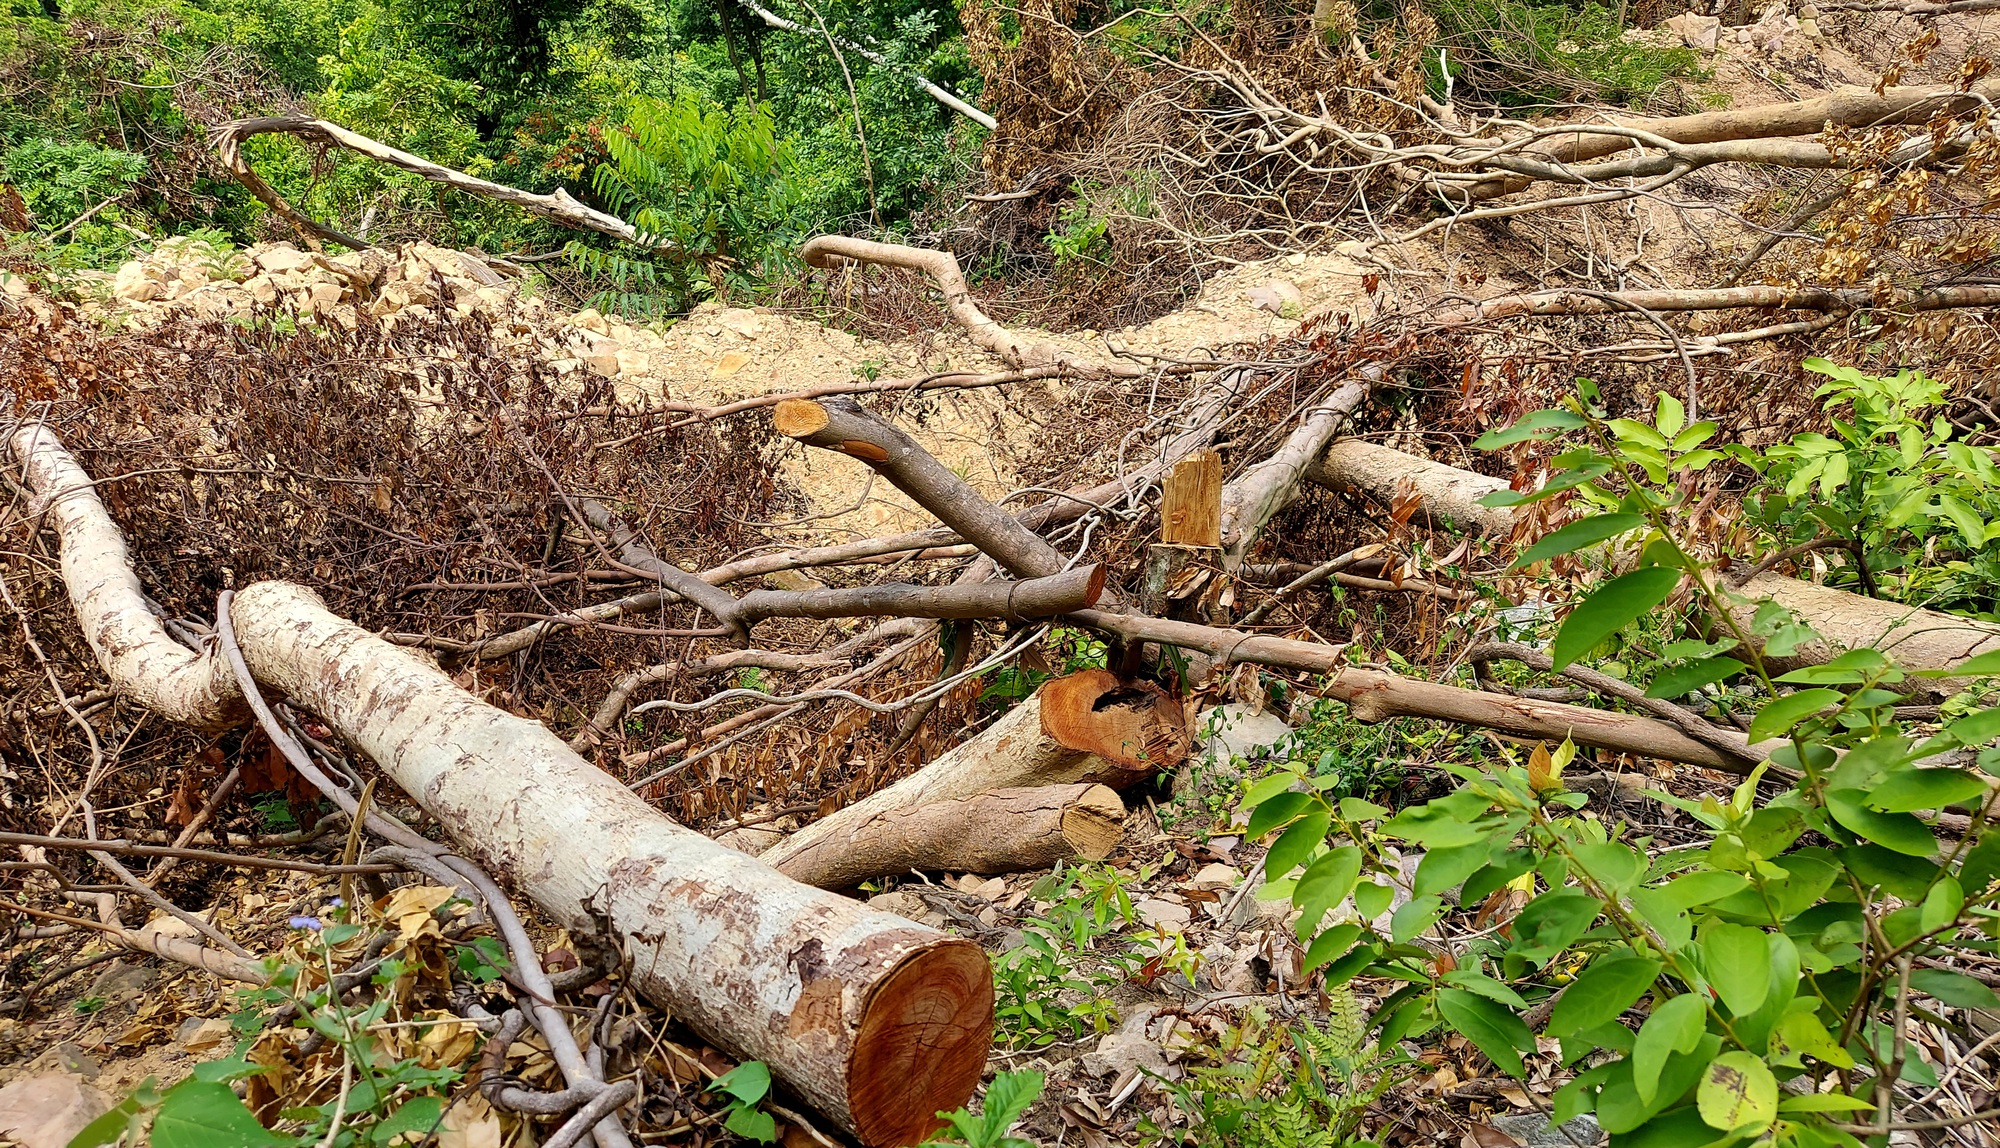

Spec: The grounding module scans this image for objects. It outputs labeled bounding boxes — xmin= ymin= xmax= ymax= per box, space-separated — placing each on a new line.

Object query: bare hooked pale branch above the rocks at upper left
xmin=216 ymin=116 xmax=642 ymax=250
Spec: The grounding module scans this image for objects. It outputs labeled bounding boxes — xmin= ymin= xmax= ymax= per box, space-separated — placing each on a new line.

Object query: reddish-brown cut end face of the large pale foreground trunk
xmin=846 ymin=940 xmax=994 ymax=1146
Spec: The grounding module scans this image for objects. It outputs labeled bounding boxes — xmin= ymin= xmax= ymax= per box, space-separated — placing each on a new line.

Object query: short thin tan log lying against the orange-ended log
xmin=764 ymin=782 xmax=1124 ymax=890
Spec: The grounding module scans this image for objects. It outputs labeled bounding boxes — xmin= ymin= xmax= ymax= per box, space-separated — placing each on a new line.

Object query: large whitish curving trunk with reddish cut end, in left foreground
xmin=12 ymin=426 xmax=992 ymax=1146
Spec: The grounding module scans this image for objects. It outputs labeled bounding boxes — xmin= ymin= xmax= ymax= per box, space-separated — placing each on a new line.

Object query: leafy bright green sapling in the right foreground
xmin=1244 ymin=374 xmax=2000 ymax=1148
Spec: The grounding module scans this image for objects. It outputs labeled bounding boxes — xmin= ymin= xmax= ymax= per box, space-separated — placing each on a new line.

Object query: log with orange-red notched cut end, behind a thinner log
xmin=760 ymin=670 xmax=1188 ymax=870
